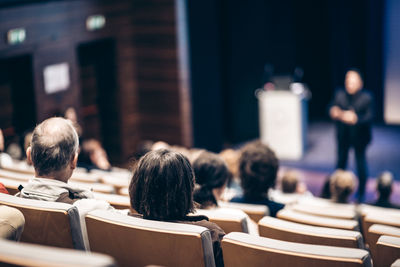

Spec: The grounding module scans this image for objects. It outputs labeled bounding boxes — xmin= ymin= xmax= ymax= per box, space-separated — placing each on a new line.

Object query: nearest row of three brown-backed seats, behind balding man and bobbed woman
xmin=0 ymin=195 xmax=370 ymax=266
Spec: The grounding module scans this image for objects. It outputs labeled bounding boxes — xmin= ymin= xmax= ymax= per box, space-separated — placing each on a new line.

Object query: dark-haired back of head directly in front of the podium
xmin=239 ymin=141 xmax=279 ymax=197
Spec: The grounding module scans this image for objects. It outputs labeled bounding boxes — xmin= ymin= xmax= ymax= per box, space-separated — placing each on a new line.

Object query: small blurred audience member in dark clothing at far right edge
xmin=373 ymin=171 xmax=400 ymax=209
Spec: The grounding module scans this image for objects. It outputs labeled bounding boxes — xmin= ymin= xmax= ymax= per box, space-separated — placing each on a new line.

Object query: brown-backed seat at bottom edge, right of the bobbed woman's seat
xmin=222 ymin=233 xmax=372 ymax=267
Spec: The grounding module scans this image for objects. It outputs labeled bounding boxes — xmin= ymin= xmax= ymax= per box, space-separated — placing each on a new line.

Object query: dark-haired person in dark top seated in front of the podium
xmin=231 ymin=141 xmax=284 ymax=217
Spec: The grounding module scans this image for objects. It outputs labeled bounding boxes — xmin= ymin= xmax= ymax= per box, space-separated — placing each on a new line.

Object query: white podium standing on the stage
xmin=256 ymin=89 xmax=308 ymax=160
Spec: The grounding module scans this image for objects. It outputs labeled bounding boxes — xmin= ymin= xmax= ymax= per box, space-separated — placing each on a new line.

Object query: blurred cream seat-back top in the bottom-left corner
xmin=0 ymin=240 xmax=116 ymax=267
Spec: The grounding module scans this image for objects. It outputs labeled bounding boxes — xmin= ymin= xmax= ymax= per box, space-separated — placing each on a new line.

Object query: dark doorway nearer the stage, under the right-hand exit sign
xmin=77 ymin=39 xmax=120 ymax=163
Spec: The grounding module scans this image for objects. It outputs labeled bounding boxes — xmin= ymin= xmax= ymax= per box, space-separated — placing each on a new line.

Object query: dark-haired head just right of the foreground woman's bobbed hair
xmin=193 ymin=151 xmax=231 ymax=207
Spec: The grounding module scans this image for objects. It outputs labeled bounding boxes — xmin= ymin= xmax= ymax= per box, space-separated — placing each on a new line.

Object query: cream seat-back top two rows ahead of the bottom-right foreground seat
xmin=277 ymin=208 xmax=359 ymax=231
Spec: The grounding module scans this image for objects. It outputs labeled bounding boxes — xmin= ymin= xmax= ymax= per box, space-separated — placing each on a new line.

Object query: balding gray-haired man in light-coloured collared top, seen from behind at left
xmin=17 ymin=117 xmax=126 ymax=249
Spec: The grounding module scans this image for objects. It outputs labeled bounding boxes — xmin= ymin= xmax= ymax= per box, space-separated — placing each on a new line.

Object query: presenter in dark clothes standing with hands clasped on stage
xmin=329 ymin=69 xmax=373 ymax=202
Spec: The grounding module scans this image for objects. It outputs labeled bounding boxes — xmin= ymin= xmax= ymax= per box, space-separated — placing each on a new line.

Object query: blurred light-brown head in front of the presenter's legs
xmin=330 ymin=170 xmax=355 ymax=203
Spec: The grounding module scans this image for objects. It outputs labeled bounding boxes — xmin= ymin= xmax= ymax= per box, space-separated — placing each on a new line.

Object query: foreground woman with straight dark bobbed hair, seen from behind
xmin=129 ymin=149 xmax=225 ymax=266
